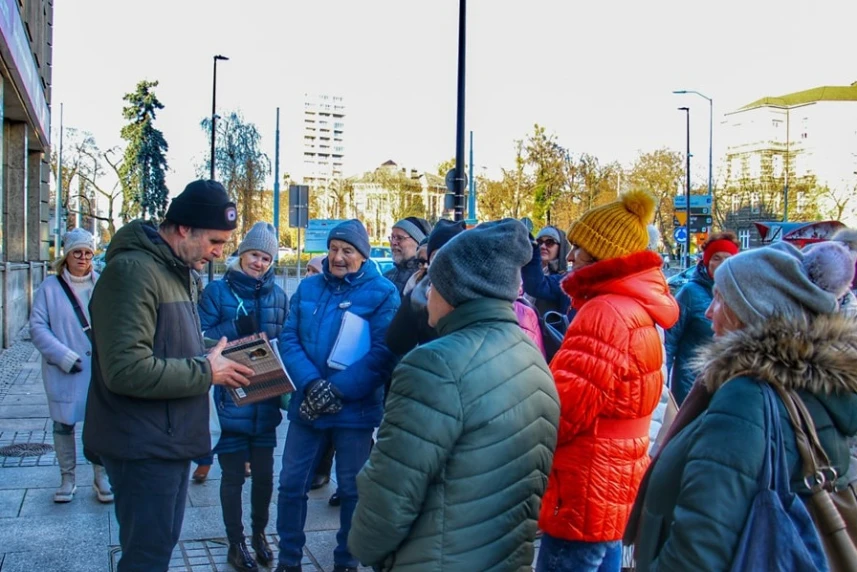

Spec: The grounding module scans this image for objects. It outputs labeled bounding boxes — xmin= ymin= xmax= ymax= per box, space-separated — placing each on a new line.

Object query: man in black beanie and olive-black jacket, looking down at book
xmin=83 ymin=181 xmax=252 ymax=572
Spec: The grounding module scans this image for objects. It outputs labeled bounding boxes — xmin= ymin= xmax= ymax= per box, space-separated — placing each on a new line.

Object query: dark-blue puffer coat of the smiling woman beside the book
xmin=199 ymin=268 xmax=289 ymax=453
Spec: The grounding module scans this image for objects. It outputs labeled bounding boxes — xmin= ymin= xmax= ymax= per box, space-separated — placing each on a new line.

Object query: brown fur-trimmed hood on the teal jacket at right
xmin=692 ymin=314 xmax=857 ymax=434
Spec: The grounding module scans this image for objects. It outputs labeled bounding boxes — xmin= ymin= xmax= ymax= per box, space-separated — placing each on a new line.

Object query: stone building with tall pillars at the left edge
xmin=0 ymin=0 xmax=53 ymax=347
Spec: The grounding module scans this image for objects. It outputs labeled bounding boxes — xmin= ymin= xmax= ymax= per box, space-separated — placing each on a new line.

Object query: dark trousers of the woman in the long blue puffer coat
xmin=217 ymin=447 xmax=274 ymax=544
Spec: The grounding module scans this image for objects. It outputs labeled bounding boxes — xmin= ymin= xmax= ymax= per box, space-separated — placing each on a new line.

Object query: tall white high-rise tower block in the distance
xmin=302 ymin=94 xmax=345 ymax=188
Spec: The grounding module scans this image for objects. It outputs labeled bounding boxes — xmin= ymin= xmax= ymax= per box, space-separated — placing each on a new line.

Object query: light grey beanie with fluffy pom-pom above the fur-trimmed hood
xmin=714 ymin=241 xmax=854 ymax=324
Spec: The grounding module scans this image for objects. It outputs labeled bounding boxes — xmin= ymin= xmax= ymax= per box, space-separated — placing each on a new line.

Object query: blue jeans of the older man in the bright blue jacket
xmin=278 ymin=423 xmax=372 ymax=567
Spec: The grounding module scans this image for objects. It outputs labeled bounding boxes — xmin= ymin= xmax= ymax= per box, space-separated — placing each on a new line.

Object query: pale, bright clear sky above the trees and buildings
xmin=52 ymin=0 xmax=857 ymax=195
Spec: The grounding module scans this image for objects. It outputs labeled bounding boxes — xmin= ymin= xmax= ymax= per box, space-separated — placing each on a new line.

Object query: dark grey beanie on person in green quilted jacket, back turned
xmin=429 ymin=218 xmax=533 ymax=307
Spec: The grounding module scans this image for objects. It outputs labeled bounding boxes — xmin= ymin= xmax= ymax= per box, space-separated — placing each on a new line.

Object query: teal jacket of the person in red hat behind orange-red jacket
xmin=664 ymin=262 xmax=714 ymax=405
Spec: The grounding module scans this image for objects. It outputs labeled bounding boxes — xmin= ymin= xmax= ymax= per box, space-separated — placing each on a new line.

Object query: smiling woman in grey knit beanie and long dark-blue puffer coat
xmin=199 ymin=222 xmax=289 ymax=570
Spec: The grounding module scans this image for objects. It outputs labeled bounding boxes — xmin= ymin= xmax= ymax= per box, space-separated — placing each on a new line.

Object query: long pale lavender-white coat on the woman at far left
xmin=30 ymin=271 xmax=98 ymax=425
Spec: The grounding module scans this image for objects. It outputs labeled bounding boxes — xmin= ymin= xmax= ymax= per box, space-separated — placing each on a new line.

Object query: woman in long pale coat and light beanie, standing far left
xmin=30 ymin=228 xmax=113 ymax=503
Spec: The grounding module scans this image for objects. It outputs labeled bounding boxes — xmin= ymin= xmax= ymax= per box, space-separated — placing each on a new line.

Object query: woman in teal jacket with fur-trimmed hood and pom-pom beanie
xmin=626 ymin=242 xmax=857 ymax=571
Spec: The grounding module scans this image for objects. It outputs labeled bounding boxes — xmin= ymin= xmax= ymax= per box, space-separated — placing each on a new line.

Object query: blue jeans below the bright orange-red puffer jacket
xmin=536 ymin=534 xmax=622 ymax=572
